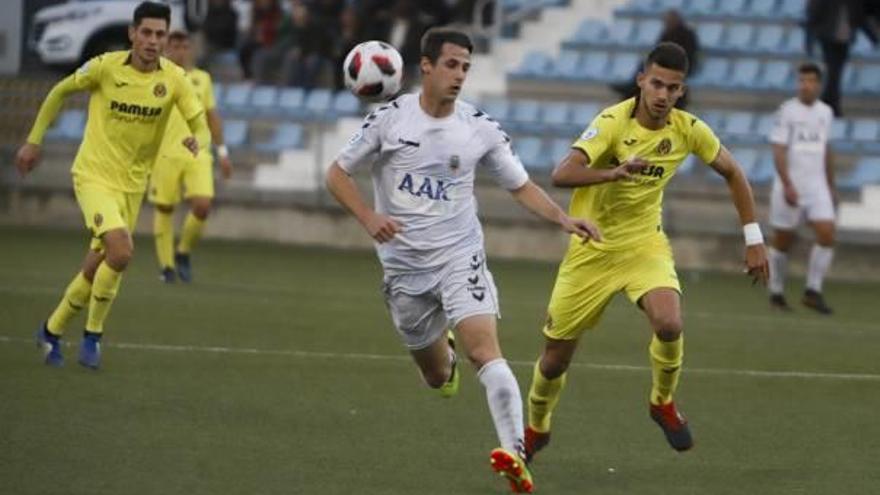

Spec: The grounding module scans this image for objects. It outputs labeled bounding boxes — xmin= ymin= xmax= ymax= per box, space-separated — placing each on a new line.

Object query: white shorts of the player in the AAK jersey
xmin=382 ymin=251 xmax=501 ymax=351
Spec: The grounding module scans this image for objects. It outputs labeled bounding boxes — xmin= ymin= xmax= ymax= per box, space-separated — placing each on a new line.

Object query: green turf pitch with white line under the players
xmin=0 ymin=228 xmax=880 ymax=495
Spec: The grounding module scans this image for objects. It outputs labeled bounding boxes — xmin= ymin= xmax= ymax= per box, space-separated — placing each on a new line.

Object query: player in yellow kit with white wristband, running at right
xmin=525 ymin=43 xmax=768 ymax=458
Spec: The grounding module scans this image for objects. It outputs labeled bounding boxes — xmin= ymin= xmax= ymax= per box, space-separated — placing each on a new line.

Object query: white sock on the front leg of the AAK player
xmin=477 ymin=358 xmax=523 ymax=454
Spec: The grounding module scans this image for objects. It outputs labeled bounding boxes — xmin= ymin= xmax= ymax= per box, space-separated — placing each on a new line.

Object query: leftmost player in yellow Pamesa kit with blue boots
xmin=16 ymin=2 xmax=206 ymax=369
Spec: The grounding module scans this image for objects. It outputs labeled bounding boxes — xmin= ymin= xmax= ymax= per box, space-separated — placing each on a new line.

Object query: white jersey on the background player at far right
xmin=769 ymin=98 xmax=834 ymax=196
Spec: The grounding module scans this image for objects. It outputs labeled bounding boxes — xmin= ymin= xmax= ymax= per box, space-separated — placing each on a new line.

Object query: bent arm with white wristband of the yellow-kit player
xmin=709 ymin=146 xmax=770 ymax=285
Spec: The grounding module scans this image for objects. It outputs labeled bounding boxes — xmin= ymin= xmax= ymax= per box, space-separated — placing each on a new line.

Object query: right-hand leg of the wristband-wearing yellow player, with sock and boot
xmin=639 ymin=288 xmax=694 ymax=451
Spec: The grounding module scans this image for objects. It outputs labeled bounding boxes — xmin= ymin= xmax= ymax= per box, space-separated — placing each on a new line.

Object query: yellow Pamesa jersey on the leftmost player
xmin=38 ymin=50 xmax=204 ymax=192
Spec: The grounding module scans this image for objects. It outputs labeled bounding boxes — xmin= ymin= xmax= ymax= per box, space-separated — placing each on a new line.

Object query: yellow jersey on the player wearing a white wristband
xmin=569 ymin=98 xmax=721 ymax=250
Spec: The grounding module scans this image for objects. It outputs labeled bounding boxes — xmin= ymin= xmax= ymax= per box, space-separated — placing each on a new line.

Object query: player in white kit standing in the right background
xmin=768 ymin=63 xmax=837 ymax=314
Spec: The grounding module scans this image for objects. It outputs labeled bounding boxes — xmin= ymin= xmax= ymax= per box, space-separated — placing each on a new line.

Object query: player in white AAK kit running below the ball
xmin=327 ymin=28 xmax=598 ymax=492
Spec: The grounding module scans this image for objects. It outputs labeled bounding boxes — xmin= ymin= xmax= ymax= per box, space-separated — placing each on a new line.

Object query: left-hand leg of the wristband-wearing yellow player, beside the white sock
xmin=525 ymin=338 xmax=578 ymax=462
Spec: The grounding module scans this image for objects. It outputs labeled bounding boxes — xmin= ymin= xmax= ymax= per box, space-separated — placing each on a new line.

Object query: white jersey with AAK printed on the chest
xmin=336 ymin=94 xmax=529 ymax=275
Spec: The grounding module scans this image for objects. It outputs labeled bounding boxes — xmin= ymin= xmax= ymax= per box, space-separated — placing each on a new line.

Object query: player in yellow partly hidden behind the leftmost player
xmin=147 ymin=31 xmax=232 ymax=283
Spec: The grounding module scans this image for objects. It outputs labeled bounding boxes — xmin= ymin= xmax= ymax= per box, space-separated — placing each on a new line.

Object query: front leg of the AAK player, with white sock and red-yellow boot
xmin=455 ymin=315 xmax=533 ymax=493
